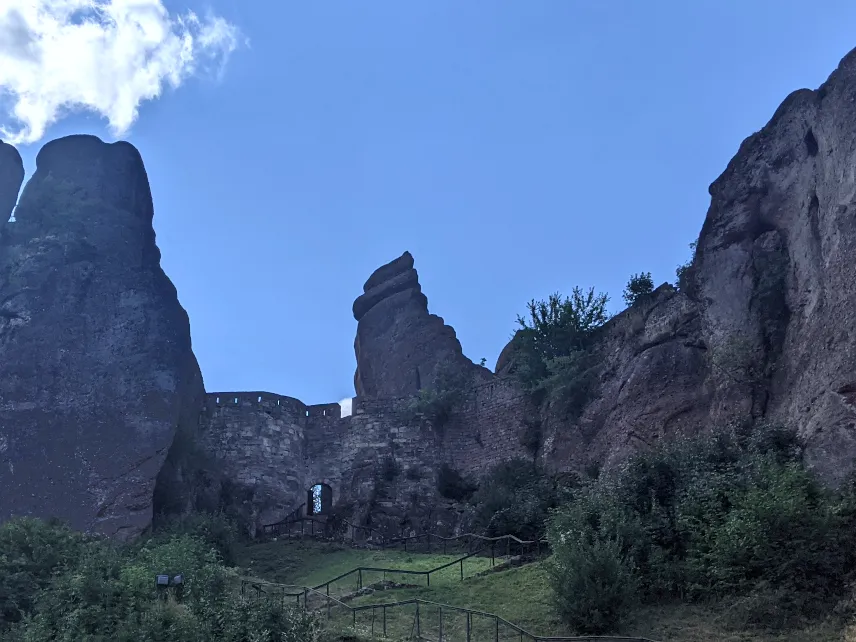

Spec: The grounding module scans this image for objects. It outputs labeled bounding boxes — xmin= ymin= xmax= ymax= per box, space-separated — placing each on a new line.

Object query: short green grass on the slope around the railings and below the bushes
xmin=234 ymin=541 xmax=856 ymax=642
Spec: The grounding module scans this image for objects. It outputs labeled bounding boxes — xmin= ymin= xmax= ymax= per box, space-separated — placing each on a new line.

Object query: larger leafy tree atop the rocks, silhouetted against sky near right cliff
xmin=516 ymin=287 xmax=609 ymax=419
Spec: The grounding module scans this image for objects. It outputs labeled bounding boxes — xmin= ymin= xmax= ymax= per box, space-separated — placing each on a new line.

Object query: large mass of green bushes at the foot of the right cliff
xmin=549 ymin=426 xmax=856 ymax=632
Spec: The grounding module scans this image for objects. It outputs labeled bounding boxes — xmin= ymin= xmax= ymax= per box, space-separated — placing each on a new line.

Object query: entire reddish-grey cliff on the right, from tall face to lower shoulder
xmin=528 ymin=47 xmax=856 ymax=483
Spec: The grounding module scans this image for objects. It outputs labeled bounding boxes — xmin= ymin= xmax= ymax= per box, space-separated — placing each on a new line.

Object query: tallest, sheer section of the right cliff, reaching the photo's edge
xmin=693 ymin=51 xmax=856 ymax=481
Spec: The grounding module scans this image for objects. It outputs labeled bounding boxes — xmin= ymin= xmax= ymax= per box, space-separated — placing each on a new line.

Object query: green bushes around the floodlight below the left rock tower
xmin=0 ymin=510 xmax=319 ymax=642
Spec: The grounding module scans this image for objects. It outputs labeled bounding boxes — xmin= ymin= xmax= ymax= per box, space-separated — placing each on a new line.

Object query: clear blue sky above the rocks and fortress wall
xmin=0 ymin=0 xmax=856 ymax=403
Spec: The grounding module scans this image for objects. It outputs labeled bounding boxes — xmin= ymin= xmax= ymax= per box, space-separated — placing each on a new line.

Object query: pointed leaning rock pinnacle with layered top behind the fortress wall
xmin=353 ymin=252 xmax=491 ymax=397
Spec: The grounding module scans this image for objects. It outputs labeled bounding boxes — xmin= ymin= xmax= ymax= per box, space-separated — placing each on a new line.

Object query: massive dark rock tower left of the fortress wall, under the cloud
xmin=0 ymin=136 xmax=204 ymax=538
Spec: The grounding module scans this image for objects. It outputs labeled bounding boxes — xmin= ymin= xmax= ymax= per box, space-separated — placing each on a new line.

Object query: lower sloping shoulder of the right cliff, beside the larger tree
xmin=543 ymin=284 xmax=711 ymax=470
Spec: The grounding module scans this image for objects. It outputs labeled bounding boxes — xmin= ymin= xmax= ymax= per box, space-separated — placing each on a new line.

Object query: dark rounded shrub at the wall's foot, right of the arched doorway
xmin=471 ymin=459 xmax=558 ymax=540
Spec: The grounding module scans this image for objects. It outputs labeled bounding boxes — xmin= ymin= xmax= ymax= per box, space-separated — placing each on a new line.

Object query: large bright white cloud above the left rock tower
xmin=0 ymin=0 xmax=242 ymax=144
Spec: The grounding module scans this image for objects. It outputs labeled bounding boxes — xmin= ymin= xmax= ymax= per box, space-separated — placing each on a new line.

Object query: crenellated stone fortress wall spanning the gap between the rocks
xmin=200 ymin=370 xmax=525 ymax=524
